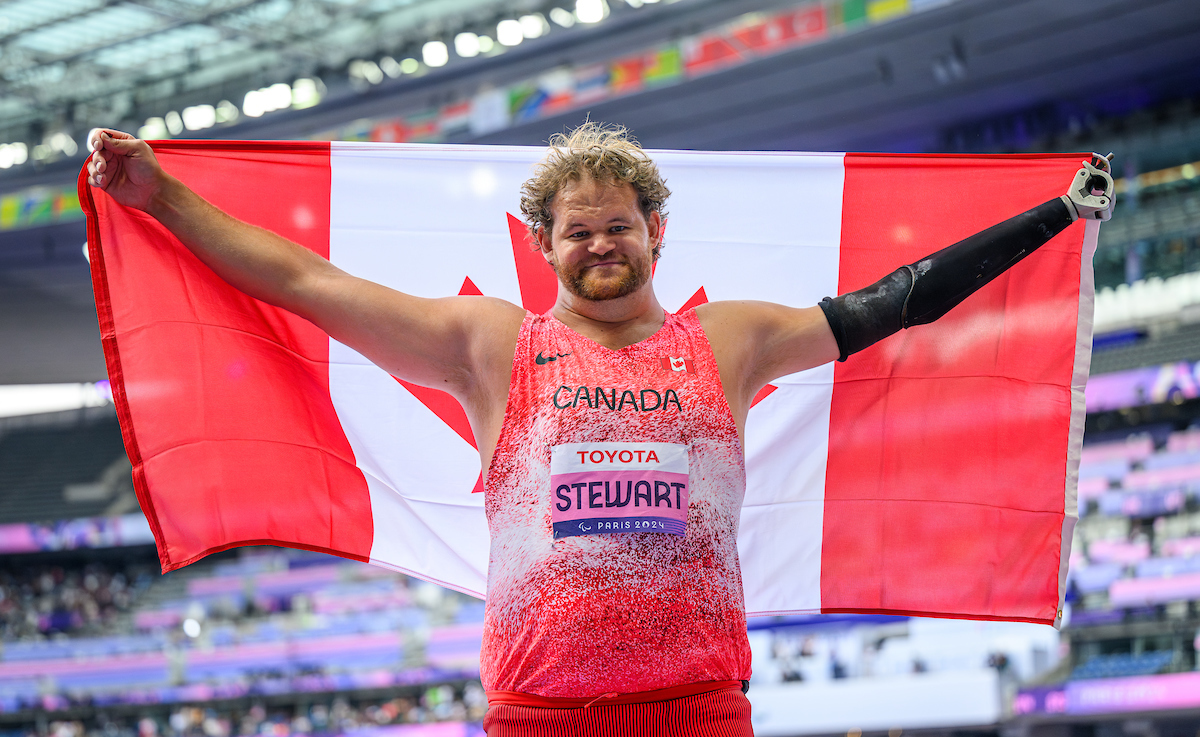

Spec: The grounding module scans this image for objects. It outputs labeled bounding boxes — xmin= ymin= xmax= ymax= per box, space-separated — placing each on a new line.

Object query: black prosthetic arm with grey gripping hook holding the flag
xmin=820 ymin=154 xmax=1112 ymax=361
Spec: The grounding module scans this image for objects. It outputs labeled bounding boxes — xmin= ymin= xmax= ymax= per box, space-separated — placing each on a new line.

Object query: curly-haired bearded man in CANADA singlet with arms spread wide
xmin=88 ymin=124 xmax=1112 ymax=735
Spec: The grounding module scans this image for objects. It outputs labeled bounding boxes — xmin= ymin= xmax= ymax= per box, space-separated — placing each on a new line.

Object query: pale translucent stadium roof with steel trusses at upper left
xmin=0 ymin=0 xmax=574 ymax=140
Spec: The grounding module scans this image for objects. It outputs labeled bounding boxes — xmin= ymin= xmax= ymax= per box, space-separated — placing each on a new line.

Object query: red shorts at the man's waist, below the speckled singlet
xmin=484 ymin=681 xmax=754 ymax=737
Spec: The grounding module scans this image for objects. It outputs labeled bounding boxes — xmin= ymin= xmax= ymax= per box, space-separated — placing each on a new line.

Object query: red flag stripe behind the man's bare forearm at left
xmin=79 ymin=142 xmax=373 ymax=571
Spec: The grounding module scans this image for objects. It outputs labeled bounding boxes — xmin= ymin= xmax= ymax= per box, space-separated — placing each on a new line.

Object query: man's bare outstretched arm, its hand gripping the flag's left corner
xmin=79 ymin=130 xmax=524 ymax=399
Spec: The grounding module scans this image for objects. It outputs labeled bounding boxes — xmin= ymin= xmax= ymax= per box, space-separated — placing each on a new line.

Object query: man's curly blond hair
xmin=521 ymin=120 xmax=671 ymax=258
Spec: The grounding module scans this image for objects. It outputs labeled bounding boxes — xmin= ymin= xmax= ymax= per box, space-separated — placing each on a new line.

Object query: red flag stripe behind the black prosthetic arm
xmin=821 ymin=154 xmax=1084 ymax=622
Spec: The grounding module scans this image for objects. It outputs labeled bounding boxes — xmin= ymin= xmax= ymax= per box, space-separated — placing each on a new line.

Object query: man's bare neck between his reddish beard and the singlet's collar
xmin=551 ymin=281 xmax=666 ymax=350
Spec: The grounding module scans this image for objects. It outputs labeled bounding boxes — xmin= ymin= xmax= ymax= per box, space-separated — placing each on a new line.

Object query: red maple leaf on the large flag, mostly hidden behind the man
xmin=394 ymin=212 xmax=775 ymax=492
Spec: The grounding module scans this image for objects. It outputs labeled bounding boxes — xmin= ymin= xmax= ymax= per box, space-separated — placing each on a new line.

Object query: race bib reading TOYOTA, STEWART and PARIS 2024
xmin=550 ymin=443 xmax=688 ymax=540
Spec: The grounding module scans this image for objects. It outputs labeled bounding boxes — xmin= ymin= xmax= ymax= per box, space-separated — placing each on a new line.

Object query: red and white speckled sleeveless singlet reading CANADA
xmin=481 ymin=311 xmax=750 ymax=697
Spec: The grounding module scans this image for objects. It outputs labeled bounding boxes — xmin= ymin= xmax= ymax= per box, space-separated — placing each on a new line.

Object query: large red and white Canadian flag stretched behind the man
xmin=79 ymin=142 xmax=1098 ymax=623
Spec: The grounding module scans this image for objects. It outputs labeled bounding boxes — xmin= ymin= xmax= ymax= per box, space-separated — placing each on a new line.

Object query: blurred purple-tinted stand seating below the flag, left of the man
xmin=0 ymin=550 xmax=482 ymax=712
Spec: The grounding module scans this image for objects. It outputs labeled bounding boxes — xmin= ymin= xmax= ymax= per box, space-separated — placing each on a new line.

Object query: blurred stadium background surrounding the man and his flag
xmin=0 ymin=0 xmax=1200 ymax=737
